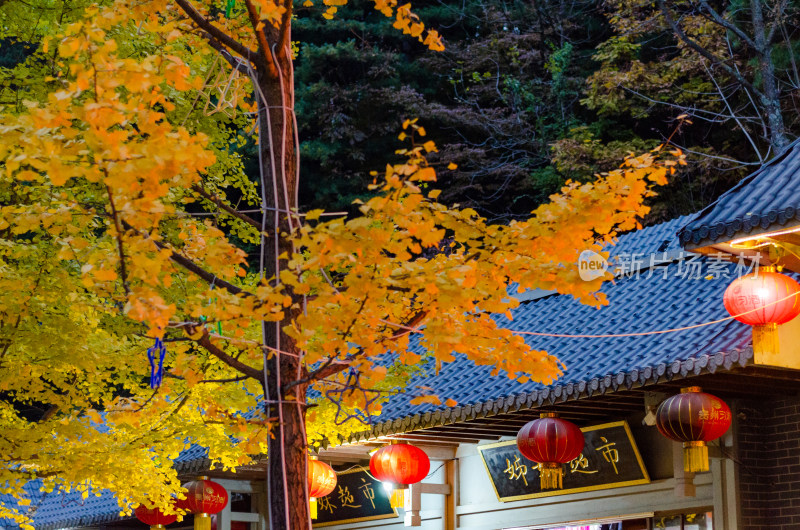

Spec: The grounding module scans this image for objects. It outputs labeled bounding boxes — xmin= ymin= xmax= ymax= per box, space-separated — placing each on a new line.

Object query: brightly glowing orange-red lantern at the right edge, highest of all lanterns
xmin=723 ymin=267 xmax=800 ymax=354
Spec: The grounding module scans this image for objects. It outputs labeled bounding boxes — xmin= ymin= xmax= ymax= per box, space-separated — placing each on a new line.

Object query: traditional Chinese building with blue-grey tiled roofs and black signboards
xmin=7 ymin=143 xmax=800 ymax=530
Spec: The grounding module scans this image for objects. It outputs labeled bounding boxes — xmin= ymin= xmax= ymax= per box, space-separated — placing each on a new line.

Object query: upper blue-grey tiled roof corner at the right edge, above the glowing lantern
xmin=679 ymin=140 xmax=800 ymax=248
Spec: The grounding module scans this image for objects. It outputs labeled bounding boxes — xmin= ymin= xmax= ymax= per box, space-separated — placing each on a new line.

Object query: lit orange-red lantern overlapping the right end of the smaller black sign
xmin=369 ymin=443 xmax=431 ymax=508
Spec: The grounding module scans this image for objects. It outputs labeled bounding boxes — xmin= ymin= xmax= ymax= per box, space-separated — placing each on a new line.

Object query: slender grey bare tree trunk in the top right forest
xmin=750 ymin=0 xmax=789 ymax=152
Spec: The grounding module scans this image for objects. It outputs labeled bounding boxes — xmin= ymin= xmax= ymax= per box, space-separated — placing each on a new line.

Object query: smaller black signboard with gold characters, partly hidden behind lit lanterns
xmin=313 ymin=467 xmax=398 ymax=528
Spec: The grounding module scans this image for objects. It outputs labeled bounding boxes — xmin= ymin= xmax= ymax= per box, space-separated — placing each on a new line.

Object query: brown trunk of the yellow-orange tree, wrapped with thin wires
xmin=257 ymin=39 xmax=311 ymax=530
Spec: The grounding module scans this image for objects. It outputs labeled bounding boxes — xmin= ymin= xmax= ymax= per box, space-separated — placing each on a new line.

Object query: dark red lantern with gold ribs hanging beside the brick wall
xmin=656 ymin=386 xmax=731 ymax=473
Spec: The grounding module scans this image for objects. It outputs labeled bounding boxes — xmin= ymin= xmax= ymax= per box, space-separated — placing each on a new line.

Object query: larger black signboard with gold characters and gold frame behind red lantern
xmin=478 ymin=421 xmax=650 ymax=502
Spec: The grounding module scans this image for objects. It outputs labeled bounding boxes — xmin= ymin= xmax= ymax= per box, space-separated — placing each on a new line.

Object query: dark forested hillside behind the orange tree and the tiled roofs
xmin=0 ymin=0 xmax=800 ymax=223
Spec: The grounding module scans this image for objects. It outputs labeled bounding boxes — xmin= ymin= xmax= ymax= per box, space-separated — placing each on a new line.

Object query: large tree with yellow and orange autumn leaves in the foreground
xmin=0 ymin=0 xmax=682 ymax=530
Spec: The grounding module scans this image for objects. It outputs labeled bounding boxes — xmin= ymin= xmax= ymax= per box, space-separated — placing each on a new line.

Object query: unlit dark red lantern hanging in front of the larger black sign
xmin=517 ymin=412 xmax=584 ymax=489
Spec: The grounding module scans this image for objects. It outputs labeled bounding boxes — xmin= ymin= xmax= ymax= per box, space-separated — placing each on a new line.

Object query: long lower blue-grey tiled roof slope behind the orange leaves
xmin=373 ymin=214 xmax=751 ymax=424
